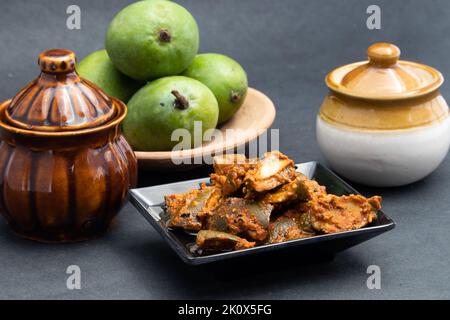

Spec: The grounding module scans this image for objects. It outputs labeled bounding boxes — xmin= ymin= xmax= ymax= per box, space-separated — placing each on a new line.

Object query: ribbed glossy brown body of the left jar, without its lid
xmin=0 ymin=99 xmax=137 ymax=242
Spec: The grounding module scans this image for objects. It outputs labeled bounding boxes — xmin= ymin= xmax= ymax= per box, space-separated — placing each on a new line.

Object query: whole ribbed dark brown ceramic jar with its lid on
xmin=0 ymin=49 xmax=137 ymax=242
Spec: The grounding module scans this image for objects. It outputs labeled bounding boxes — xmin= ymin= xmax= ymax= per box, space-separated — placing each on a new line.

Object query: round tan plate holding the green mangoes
xmin=135 ymin=88 xmax=276 ymax=171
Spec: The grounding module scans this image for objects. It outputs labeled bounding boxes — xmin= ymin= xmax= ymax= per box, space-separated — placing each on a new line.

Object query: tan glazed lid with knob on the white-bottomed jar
xmin=325 ymin=43 xmax=444 ymax=100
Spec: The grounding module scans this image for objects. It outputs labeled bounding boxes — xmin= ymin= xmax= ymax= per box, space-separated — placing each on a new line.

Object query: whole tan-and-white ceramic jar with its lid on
xmin=316 ymin=43 xmax=450 ymax=186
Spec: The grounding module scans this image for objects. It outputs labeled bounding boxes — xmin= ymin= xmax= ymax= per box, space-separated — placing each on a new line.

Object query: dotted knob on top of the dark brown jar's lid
xmin=38 ymin=49 xmax=75 ymax=74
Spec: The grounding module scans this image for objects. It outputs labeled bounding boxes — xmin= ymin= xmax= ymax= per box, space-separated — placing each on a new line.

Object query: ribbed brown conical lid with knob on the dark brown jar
xmin=5 ymin=49 xmax=116 ymax=131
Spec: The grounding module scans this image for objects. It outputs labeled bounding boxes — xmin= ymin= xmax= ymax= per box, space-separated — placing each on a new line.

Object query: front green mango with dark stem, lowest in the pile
xmin=122 ymin=76 xmax=219 ymax=151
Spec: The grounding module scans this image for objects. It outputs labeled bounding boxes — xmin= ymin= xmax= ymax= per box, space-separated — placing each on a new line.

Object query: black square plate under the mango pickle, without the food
xmin=130 ymin=161 xmax=395 ymax=265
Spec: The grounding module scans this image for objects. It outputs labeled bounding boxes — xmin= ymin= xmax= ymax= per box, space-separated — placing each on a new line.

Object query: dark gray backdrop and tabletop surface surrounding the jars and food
xmin=0 ymin=0 xmax=450 ymax=299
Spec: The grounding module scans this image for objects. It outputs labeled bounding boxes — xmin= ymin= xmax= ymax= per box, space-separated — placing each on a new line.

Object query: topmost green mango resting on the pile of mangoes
xmin=106 ymin=0 xmax=199 ymax=80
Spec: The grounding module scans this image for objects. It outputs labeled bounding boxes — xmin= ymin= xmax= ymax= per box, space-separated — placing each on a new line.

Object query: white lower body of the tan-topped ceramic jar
xmin=316 ymin=115 xmax=450 ymax=187
